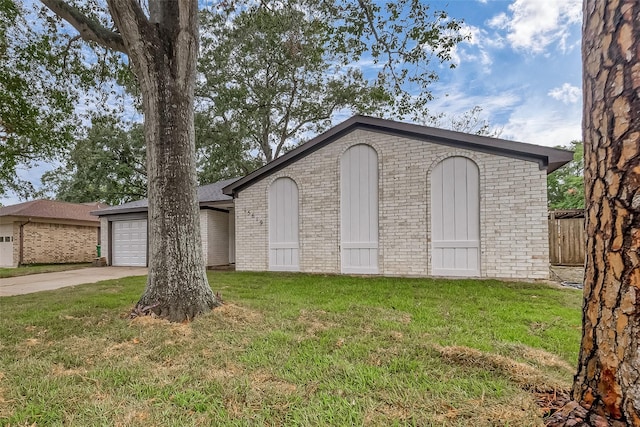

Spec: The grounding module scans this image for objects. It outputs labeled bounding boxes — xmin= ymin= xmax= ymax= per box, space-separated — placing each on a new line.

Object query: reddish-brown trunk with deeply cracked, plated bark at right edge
xmin=552 ymin=0 xmax=640 ymax=426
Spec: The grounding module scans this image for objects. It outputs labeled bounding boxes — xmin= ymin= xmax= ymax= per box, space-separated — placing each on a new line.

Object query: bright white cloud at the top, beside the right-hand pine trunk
xmin=487 ymin=0 xmax=582 ymax=53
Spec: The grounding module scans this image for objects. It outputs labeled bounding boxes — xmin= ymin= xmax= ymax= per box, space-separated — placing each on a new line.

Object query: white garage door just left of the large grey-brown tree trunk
xmin=111 ymin=219 xmax=147 ymax=267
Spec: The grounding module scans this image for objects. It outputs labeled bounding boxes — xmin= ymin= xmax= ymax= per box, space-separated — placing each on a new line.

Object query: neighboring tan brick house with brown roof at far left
xmin=0 ymin=200 xmax=106 ymax=267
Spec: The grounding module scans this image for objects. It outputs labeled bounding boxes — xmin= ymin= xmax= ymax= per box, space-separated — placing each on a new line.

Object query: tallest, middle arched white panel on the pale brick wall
xmin=340 ymin=144 xmax=378 ymax=274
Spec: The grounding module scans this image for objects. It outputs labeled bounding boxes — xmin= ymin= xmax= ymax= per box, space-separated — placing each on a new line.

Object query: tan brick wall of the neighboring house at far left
xmin=21 ymin=222 xmax=98 ymax=264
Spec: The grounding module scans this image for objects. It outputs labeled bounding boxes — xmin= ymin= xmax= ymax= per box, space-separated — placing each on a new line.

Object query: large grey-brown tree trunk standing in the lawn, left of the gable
xmin=109 ymin=0 xmax=219 ymax=322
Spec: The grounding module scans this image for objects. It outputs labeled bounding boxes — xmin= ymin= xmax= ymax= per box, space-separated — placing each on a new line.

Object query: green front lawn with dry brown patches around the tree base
xmin=0 ymin=272 xmax=581 ymax=426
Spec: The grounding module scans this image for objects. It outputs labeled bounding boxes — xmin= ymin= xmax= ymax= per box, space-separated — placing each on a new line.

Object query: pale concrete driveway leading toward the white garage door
xmin=0 ymin=267 xmax=147 ymax=297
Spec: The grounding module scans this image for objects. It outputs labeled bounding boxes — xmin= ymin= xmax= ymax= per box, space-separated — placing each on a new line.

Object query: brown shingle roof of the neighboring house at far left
xmin=0 ymin=200 xmax=108 ymax=222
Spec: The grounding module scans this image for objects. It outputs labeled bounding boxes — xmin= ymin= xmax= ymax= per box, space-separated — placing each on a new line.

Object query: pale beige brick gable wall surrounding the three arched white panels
xmin=235 ymin=130 xmax=548 ymax=279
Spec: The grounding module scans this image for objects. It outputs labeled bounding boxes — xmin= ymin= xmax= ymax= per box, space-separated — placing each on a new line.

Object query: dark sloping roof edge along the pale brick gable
xmin=222 ymin=116 xmax=573 ymax=195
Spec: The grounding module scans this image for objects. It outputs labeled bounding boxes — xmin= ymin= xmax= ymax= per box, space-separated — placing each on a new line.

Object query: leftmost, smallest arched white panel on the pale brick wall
xmin=269 ymin=178 xmax=300 ymax=271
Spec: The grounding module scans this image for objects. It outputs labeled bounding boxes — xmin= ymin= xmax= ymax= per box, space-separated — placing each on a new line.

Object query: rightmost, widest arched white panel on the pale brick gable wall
xmin=431 ymin=157 xmax=480 ymax=276
